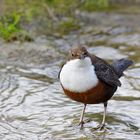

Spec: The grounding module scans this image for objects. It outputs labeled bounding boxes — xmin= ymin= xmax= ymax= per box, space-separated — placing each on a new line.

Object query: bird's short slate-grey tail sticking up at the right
xmin=111 ymin=59 xmax=133 ymax=77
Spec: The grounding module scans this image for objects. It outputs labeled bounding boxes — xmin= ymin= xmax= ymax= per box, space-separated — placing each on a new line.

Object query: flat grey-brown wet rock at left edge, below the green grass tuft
xmin=0 ymin=40 xmax=61 ymax=67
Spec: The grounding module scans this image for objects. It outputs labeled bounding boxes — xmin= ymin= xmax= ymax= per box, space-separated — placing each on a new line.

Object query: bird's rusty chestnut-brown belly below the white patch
xmin=62 ymin=81 xmax=116 ymax=104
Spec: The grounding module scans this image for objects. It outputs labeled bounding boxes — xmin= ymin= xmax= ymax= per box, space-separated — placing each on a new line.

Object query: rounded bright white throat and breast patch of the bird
xmin=60 ymin=57 xmax=98 ymax=93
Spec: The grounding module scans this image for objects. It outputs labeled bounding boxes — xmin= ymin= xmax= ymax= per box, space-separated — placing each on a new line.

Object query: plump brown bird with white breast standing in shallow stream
xmin=59 ymin=46 xmax=133 ymax=130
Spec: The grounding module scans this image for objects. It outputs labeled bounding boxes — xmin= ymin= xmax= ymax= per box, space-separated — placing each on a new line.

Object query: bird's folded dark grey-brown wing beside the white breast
xmin=91 ymin=56 xmax=121 ymax=86
